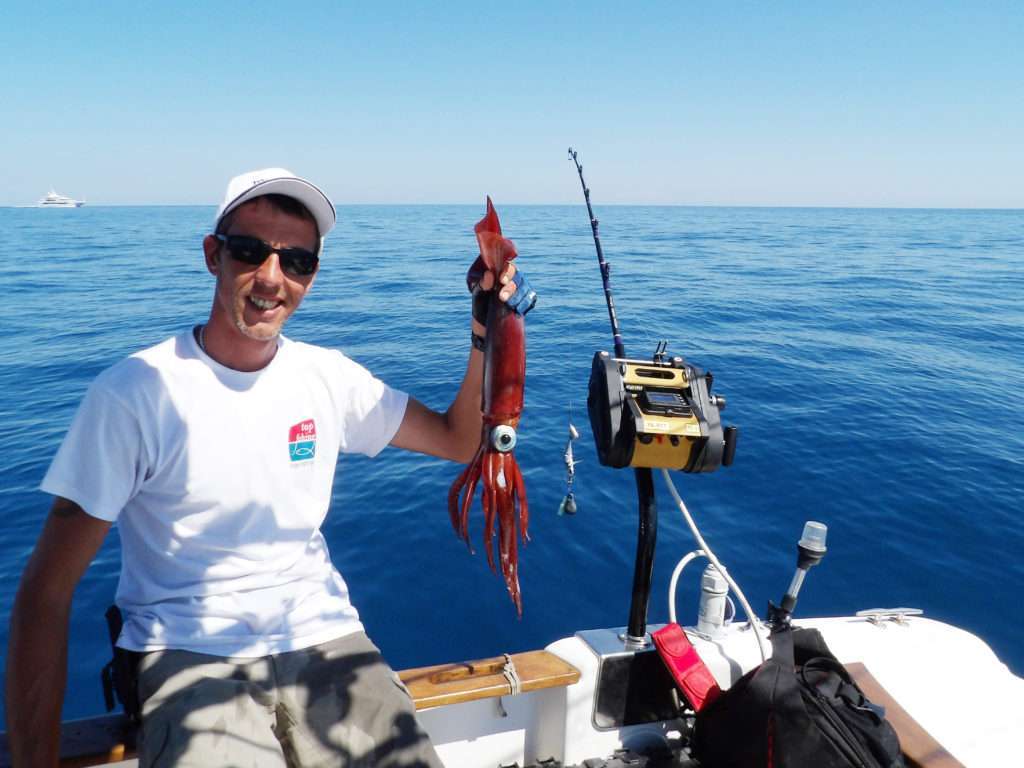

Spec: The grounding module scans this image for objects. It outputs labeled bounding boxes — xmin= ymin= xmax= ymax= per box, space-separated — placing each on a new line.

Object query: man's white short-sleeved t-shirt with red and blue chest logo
xmin=41 ymin=331 xmax=408 ymax=656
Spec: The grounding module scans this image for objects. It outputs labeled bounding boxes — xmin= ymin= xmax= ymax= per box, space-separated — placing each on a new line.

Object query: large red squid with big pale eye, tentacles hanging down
xmin=449 ymin=198 xmax=529 ymax=616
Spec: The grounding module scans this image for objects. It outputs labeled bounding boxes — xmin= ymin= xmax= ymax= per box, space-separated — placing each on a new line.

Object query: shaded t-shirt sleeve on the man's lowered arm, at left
xmin=40 ymin=379 xmax=146 ymax=522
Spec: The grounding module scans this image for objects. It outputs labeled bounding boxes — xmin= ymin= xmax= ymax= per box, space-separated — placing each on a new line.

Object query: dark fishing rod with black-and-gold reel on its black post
xmin=569 ymin=146 xmax=737 ymax=650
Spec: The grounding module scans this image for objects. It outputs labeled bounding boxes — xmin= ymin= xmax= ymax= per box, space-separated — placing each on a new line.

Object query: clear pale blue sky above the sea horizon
xmin=0 ymin=0 xmax=1024 ymax=208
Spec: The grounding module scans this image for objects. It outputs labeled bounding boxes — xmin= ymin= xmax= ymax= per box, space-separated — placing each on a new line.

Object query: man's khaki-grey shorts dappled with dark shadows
xmin=138 ymin=632 xmax=442 ymax=768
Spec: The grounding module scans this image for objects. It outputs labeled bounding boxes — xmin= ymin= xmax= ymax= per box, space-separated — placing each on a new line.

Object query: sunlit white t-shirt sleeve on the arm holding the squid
xmin=329 ymin=352 xmax=409 ymax=457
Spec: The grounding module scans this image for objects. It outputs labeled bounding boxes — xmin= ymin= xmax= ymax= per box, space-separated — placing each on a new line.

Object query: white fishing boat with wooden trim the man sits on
xmin=0 ymin=507 xmax=1024 ymax=768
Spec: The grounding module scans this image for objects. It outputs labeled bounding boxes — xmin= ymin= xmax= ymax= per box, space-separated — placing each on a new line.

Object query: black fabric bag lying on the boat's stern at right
xmin=691 ymin=625 xmax=905 ymax=768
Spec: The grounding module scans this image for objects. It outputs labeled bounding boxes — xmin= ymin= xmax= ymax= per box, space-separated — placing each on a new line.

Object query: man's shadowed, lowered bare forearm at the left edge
xmin=6 ymin=574 xmax=71 ymax=768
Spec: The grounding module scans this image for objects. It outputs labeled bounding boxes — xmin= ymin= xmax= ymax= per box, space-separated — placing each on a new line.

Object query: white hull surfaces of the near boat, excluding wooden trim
xmin=419 ymin=617 xmax=1024 ymax=768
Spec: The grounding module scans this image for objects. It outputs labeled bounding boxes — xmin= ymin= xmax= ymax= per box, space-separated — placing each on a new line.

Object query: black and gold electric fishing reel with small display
xmin=587 ymin=341 xmax=738 ymax=472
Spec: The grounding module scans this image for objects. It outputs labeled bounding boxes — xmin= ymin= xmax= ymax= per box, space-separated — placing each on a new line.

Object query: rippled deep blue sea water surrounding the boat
xmin=0 ymin=201 xmax=1024 ymax=717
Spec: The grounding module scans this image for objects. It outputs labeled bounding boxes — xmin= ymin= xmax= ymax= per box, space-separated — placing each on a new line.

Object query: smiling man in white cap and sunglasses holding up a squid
xmin=6 ymin=168 xmax=536 ymax=766
